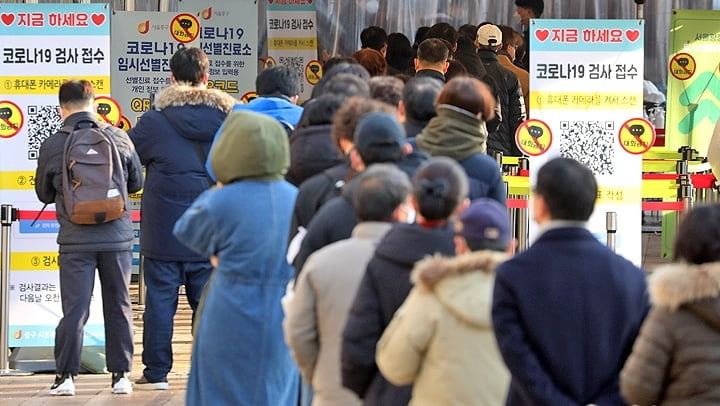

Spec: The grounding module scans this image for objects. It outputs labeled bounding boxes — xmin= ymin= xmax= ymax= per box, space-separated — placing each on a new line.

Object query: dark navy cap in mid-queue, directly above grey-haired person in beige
xmin=354 ymin=111 xmax=407 ymax=165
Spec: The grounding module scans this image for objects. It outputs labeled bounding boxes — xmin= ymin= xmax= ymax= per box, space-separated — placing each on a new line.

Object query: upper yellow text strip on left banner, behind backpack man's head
xmin=0 ymin=75 xmax=110 ymax=96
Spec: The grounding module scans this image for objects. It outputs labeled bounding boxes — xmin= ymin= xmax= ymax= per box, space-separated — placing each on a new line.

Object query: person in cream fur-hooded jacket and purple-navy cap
xmin=376 ymin=198 xmax=514 ymax=406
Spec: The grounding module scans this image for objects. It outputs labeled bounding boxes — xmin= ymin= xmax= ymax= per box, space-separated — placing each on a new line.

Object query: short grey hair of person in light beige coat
xmin=352 ymin=164 xmax=411 ymax=222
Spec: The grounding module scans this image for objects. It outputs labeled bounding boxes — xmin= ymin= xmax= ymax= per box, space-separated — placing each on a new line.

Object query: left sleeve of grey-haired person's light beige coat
xmin=283 ymin=257 xmax=320 ymax=383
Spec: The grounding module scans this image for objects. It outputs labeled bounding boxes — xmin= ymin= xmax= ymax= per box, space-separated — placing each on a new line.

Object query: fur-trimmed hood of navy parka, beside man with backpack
xmin=155 ymin=84 xmax=238 ymax=142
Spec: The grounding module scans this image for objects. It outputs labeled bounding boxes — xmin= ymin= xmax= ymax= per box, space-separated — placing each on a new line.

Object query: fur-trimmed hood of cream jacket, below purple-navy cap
xmin=411 ymin=251 xmax=507 ymax=327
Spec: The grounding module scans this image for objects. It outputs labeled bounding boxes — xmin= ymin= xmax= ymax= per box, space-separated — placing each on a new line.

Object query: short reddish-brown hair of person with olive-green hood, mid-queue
xmin=436 ymin=76 xmax=495 ymax=121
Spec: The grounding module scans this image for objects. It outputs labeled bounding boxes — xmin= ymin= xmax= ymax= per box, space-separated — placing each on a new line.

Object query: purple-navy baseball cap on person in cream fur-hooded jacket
xmin=457 ymin=197 xmax=510 ymax=251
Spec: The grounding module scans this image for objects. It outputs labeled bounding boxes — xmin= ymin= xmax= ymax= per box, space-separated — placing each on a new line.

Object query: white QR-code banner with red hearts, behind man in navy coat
xmin=517 ymin=19 xmax=644 ymax=264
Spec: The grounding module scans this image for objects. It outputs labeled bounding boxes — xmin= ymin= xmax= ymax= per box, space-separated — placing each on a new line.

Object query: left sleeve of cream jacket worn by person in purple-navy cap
xmin=375 ymin=288 xmax=435 ymax=386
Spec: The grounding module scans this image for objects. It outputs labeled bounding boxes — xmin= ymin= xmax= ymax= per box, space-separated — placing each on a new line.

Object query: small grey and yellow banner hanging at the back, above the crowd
xmin=263 ymin=0 xmax=322 ymax=101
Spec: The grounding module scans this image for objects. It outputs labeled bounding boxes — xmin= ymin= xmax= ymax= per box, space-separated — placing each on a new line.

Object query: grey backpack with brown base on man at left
xmin=60 ymin=121 xmax=128 ymax=224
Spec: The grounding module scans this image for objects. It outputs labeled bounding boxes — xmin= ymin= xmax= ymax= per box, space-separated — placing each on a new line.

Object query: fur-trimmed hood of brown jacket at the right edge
xmin=648 ymin=262 xmax=720 ymax=331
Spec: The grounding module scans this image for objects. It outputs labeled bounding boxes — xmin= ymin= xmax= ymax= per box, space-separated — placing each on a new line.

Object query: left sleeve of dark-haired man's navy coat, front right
xmin=492 ymin=265 xmax=577 ymax=406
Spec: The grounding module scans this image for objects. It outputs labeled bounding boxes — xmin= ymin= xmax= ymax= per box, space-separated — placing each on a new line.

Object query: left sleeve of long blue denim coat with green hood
xmin=173 ymin=188 xmax=218 ymax=258
